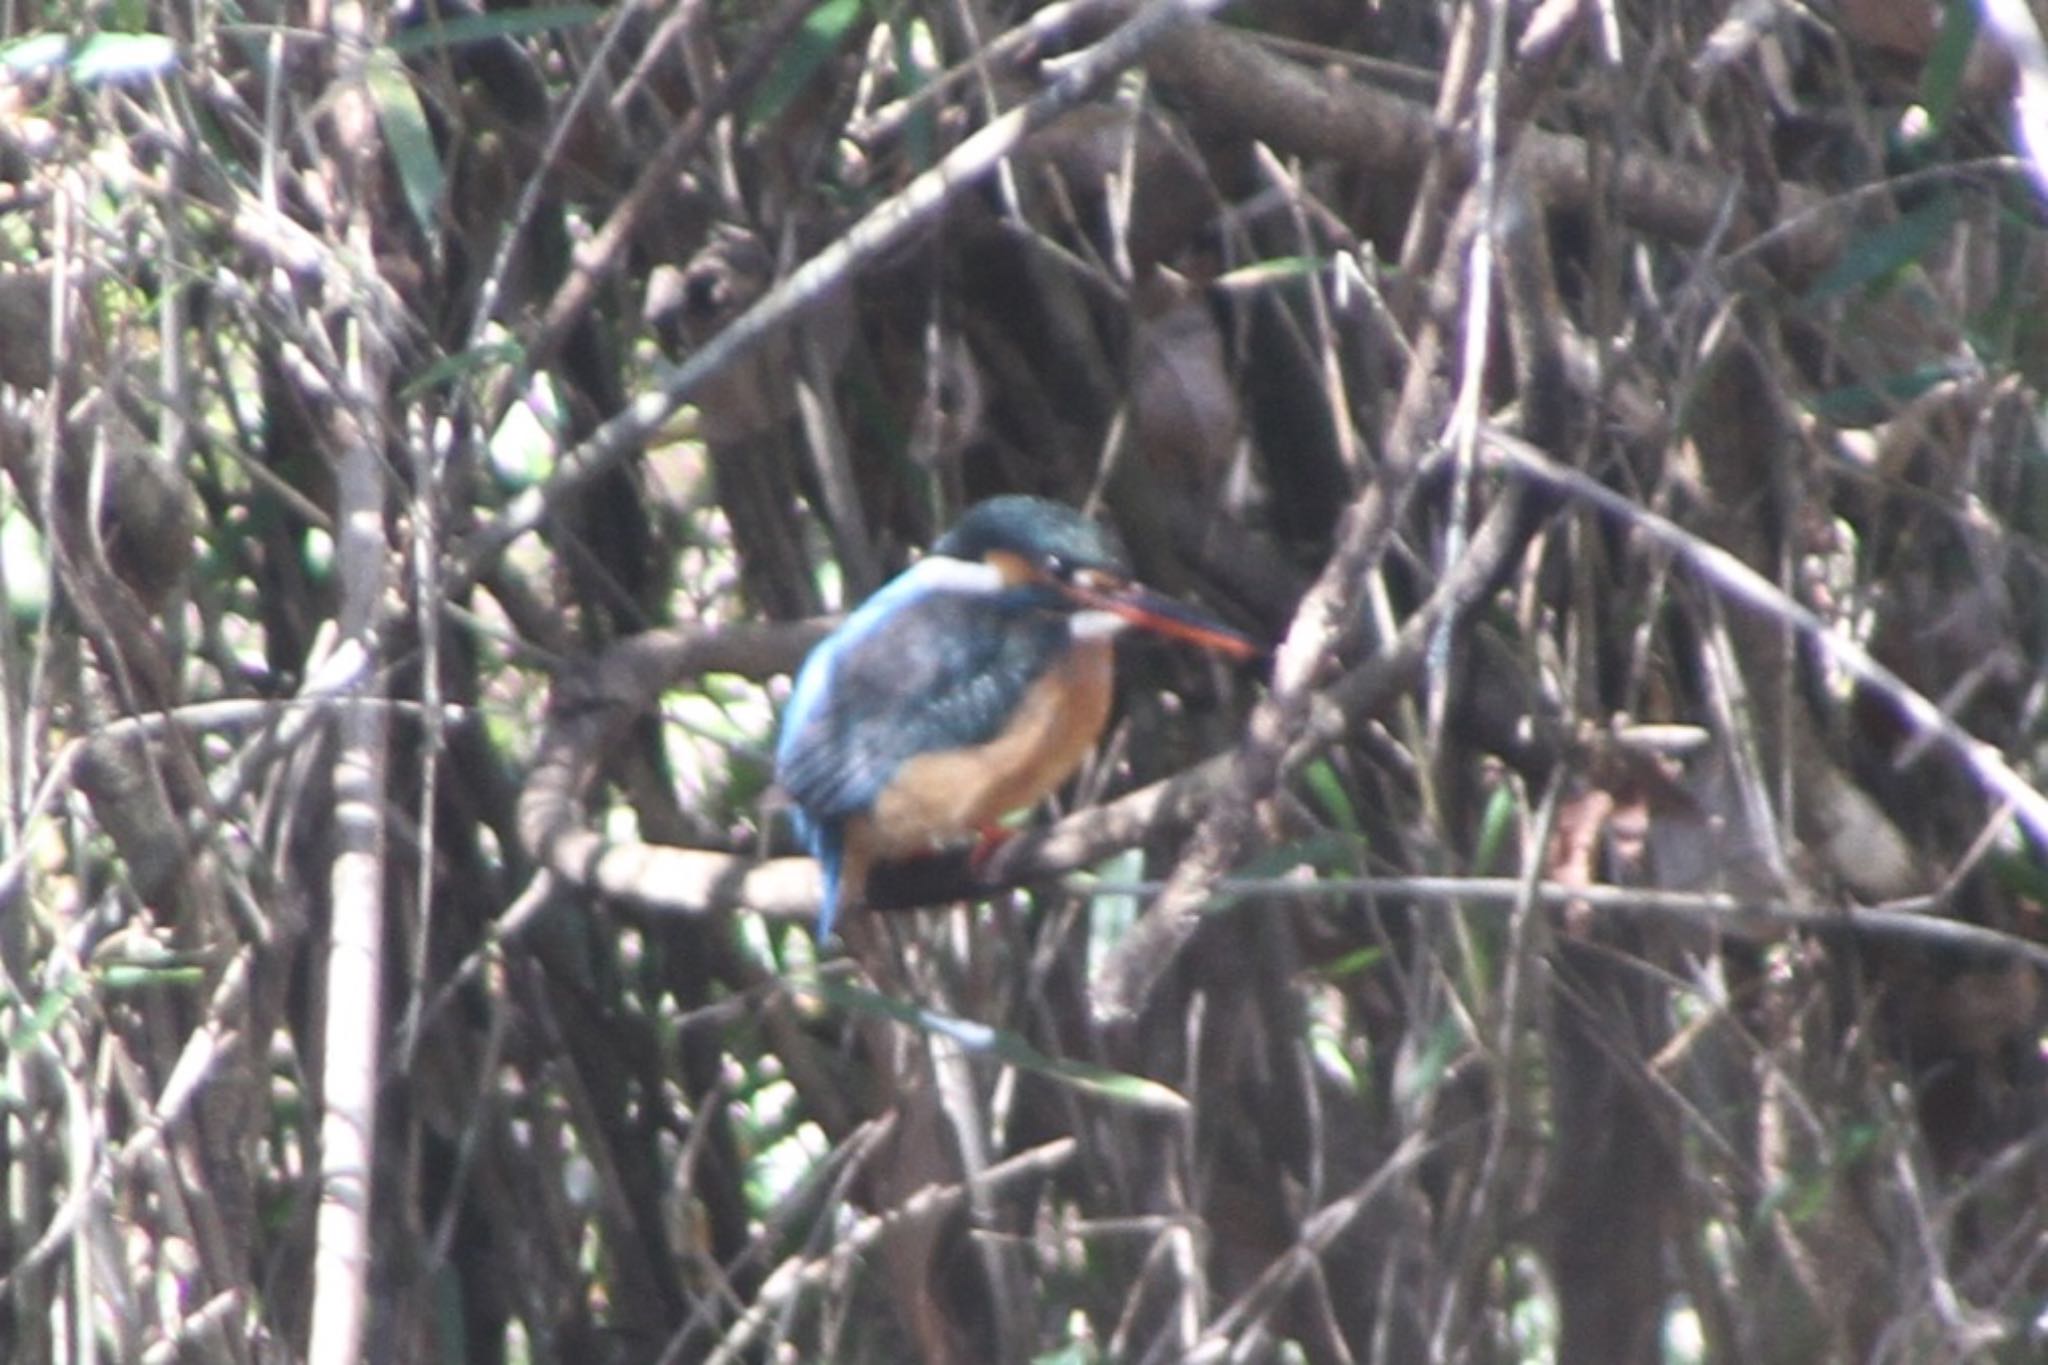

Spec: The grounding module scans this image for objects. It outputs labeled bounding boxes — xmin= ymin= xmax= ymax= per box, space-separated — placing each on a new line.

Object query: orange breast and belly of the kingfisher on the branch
xmin=866 ymin=641 xmax=1116 ymax=857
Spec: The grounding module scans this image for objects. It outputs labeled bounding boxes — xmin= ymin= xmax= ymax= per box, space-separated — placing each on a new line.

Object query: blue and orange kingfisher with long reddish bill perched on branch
xmin=776 ymin=495 xmax=1260 ymax=941
